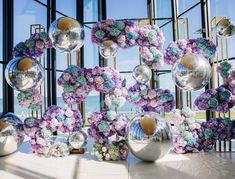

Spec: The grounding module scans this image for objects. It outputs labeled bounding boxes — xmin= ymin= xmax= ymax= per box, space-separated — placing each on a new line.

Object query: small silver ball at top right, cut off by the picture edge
xmin=215 ymin=18 xmax=235 ymax=37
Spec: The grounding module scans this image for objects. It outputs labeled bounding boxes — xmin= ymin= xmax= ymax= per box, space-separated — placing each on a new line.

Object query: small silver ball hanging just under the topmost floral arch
xmin=99 ymin=40 xmax=118 ymax=59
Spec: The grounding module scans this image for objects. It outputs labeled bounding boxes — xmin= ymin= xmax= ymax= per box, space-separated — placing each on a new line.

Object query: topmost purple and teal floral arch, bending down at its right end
xmin=91 ymin=19 xmax=165 ymax=70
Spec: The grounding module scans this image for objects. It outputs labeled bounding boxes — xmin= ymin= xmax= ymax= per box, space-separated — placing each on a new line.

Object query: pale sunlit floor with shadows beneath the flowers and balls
xmin=0 ymin=140 xmax=235 ymax=179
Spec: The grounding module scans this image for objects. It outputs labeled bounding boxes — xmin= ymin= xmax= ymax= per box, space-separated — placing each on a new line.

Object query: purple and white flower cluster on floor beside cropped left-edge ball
xmin=24 ymin=105 xmax=83 ymax=157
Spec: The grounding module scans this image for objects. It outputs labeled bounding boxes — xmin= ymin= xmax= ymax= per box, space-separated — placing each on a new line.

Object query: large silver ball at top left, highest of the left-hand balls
xmin=49 ymin=17 xmax=85 ymax=53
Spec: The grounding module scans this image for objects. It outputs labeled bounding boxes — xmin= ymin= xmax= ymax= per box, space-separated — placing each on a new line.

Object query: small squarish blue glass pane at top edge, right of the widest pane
xmin=155 ymin=0 xmax=172 ymax=18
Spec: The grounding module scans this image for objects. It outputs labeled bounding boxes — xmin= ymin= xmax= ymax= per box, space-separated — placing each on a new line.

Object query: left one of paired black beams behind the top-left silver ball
xmin=46 ymin=0 xmax=51 ymax=106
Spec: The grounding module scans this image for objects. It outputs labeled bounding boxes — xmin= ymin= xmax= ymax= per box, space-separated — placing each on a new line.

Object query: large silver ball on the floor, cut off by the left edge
xmin=0 ymin=113 xmax=24 ymax=156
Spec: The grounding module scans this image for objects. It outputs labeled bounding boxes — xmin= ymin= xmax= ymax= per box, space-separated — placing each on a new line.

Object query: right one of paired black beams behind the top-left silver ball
xmin=51 ymin=0 xmax=57 ymax=105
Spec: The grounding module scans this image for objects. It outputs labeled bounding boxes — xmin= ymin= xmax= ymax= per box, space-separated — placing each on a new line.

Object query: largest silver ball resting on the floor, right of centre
xmin=127 ymin=112 xmax=172 ymax=162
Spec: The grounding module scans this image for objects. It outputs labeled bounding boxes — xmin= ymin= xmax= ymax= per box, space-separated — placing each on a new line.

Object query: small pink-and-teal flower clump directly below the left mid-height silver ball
xmin=17 ymin=89 xmax=42 ymax=111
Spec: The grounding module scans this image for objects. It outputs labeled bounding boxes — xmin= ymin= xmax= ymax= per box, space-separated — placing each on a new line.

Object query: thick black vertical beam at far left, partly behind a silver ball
xmin=2 ymin=0 xmax=14 ymax=112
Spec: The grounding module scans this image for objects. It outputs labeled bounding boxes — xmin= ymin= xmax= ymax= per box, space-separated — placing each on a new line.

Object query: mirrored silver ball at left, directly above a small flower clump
xmin=5 ymin=57 xmax=44 ymax=91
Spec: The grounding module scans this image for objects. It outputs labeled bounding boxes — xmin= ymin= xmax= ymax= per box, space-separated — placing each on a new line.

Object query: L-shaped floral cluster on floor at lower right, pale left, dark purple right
xmin=172 ymin=108 xmax=235 ymax=153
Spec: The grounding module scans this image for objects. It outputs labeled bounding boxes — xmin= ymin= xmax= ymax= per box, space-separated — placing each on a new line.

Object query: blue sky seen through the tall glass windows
xmin=0 ymin=0 xmax=235 ymax=111
